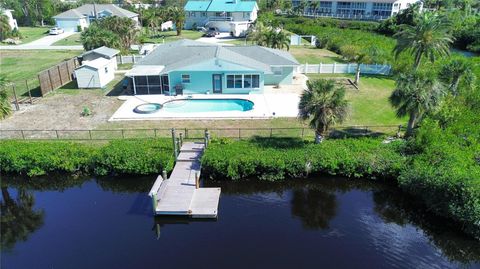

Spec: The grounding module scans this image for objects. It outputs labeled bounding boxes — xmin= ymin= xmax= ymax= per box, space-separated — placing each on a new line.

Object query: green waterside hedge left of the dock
xmin=0 ymin=140 xmax=173 ymax=177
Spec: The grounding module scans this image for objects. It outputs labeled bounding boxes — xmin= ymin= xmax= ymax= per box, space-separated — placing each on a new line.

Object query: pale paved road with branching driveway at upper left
xmin=0 ymin=32 xmax=83 ymax=50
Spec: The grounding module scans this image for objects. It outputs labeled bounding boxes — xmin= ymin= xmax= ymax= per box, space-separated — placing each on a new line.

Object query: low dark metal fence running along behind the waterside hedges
xmin=0 ymin=125 xmax=403 ymax=140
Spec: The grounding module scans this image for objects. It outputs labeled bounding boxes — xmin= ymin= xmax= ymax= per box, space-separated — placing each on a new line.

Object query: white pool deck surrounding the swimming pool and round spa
xmin=109 ymin=93 xmax=300 ymax=121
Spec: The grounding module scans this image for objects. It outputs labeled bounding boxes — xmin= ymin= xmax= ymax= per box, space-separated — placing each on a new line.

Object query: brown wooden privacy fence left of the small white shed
xmin=38 ymin=57 xmax=80 ymax=96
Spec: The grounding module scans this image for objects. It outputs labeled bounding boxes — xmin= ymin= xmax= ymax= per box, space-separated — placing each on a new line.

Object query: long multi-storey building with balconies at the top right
xmin=292 ymin=0 xmax=420 ymax=20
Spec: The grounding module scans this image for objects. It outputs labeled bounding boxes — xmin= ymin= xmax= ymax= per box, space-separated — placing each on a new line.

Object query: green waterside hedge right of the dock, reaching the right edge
xmin=202 ymin=138 xmax=480 ymax=239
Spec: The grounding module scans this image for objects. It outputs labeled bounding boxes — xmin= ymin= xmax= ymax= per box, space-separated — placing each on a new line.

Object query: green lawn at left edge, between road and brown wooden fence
xmin=0 ymin=50 xmax=80 ymax=95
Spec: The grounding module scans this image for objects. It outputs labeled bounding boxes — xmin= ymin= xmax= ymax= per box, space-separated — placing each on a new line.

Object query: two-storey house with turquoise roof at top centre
xmin=185 ymin=0 xmax=258 ymax=32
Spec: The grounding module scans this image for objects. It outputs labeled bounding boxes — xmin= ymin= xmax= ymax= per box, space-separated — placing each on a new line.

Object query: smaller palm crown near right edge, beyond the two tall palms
xmin=439 ymin=57 xmax=475 ymax=96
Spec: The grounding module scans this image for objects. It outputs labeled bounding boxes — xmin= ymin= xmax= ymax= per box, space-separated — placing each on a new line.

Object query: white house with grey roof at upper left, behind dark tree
xmin=53 ymin=4 xmax=138 ymax=32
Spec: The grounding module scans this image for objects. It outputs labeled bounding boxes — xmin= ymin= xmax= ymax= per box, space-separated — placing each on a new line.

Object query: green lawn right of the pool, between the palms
xmin=308 ymin=74 xmax=406 ymax=126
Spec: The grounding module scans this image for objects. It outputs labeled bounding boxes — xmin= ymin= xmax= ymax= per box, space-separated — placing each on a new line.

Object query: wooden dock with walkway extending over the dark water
xmin=149 ymin=142 xmax=220 ymax=218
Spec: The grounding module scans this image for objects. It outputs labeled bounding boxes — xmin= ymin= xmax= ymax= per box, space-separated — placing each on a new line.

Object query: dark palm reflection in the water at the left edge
xmin=0 ymin=186 xmax=45 ymax=251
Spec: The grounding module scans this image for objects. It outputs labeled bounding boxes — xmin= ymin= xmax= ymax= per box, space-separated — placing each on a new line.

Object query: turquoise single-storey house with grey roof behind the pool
xmin=126 ymin=40 xmax=298 ymax=95
